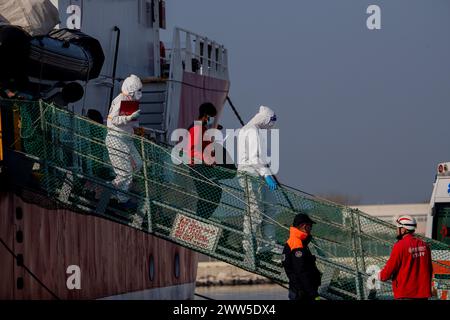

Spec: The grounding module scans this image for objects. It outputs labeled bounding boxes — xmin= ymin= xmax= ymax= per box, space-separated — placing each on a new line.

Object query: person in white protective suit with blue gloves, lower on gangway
xmin=237 ymin=106 xmax=277 ymax=266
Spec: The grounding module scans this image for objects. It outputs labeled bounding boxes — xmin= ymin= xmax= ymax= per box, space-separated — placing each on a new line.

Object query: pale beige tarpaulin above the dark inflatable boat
xmin=0 ymin=0 xmax=59 ymax=36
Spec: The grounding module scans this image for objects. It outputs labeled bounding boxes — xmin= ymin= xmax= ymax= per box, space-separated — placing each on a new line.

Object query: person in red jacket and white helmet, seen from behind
xmin=379 ymin=215 xmax=433 ymax=299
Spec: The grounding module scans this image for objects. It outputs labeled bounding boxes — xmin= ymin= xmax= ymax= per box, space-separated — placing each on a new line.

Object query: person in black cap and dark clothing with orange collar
xmin=281 ymin=213 xmax=322 ymax=301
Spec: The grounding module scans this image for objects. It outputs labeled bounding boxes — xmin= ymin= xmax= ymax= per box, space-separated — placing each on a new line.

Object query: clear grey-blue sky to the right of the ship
xmin=163 ymin=0 xmax=450 ymax=204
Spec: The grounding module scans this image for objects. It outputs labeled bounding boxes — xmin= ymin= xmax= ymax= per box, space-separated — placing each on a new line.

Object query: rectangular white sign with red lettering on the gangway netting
xmin=170 ymin=214 xmax=220 ymax=251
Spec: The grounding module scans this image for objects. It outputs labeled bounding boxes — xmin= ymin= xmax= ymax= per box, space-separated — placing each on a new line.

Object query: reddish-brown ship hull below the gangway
xmin=0 ymin=192 xmax=197 ymax=299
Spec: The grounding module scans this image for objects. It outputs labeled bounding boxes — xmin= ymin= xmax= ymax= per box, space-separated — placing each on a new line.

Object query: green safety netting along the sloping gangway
xmin=1 ymin=101 xmax=450 ymax=299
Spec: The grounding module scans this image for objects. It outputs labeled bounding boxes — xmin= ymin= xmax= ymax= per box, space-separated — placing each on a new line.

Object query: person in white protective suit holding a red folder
xmin=106 ymin=74 xmax=142 ymax=209
